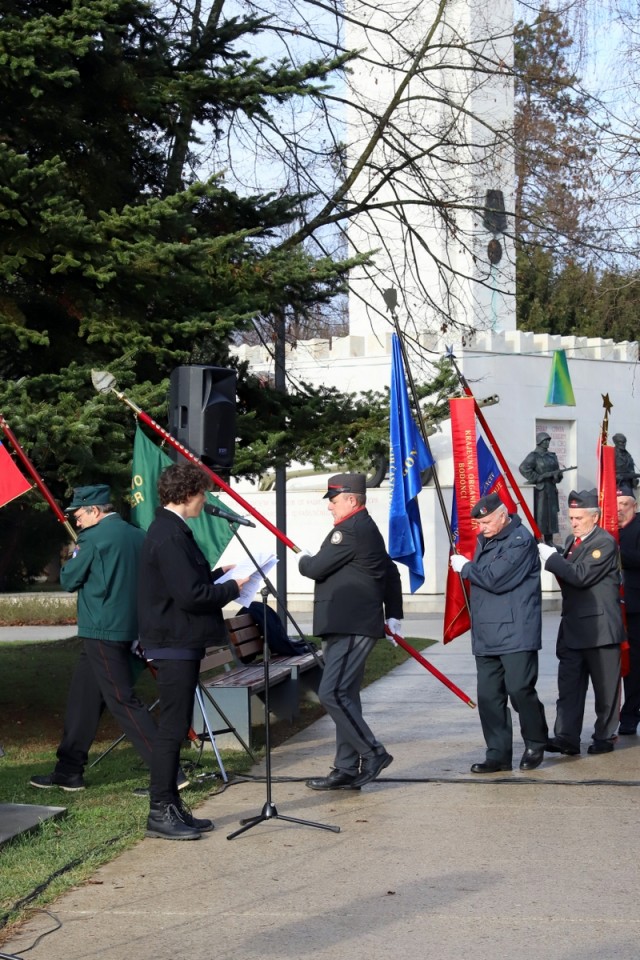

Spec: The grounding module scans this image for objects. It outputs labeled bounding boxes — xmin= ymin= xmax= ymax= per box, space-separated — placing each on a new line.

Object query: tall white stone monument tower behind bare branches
xmin=345 ymin=0 xmax=515 ymax=344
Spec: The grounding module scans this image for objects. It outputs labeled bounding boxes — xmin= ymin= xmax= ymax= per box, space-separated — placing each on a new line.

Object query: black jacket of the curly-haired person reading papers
xmin=138 ymin=507 xmax=239 ymax=649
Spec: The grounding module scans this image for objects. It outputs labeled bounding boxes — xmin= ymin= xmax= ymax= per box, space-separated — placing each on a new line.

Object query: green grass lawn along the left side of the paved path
xmin=0 ymin=632 xmax=429 ymax=943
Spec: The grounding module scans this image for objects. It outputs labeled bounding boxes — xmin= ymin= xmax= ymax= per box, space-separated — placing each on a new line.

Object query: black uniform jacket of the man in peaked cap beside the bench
xmin=299 ymin=510 xmax=402 ymax=637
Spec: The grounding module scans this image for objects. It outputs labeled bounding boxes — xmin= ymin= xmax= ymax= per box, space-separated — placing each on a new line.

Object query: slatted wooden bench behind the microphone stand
xmin=195 ymin=614 xmax=322 ymax=748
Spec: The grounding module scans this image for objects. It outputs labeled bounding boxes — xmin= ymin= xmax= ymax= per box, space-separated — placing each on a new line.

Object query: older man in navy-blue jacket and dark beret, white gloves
xmin=451 ymin=493 xmax=548 ymax=773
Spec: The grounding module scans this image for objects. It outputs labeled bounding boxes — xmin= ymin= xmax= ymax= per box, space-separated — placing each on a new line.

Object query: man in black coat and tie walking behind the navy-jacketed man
xmin=538 ymin=489 xmax=624 ymax=756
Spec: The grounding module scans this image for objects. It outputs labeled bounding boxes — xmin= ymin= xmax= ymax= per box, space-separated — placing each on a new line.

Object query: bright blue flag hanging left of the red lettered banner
xmin=389 ymin=333 xmax=434 ymax=593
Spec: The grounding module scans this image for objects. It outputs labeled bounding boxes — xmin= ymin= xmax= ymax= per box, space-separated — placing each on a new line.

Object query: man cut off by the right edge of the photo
xmin=616 ymin=484 xmax=640 ymax=736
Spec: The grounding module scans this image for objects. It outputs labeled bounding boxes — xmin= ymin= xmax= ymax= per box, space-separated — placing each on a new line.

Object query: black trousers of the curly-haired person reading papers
xmin=150 ymin=659 xmax=200 ymax=803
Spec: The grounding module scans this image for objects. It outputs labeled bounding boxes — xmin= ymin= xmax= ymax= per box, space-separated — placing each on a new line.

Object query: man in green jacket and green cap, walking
xmin=30 ymin=484 xmax=161 ymax=791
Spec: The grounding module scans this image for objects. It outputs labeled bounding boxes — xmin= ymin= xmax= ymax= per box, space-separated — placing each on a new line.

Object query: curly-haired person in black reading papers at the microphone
xmin=138 ymin=463 xmax=246 ymax=840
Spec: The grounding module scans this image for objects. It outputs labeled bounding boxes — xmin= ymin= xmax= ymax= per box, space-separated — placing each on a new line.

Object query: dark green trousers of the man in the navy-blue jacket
xmin=476 ymin=650 xmax=549 ymax=764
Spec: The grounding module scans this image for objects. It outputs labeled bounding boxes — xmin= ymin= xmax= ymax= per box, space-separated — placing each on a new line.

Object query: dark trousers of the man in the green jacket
xmin=56 ymin=638 xmax=156 ymax=774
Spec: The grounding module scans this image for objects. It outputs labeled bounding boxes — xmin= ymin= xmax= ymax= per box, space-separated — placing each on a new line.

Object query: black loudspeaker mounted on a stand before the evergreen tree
xmin=169 ymin=364 xmax=236 ymax=468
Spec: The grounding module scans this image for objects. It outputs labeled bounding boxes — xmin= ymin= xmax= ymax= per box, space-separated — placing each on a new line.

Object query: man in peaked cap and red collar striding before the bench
xmin=299 ymin=473 xmax=402 ymax=790
